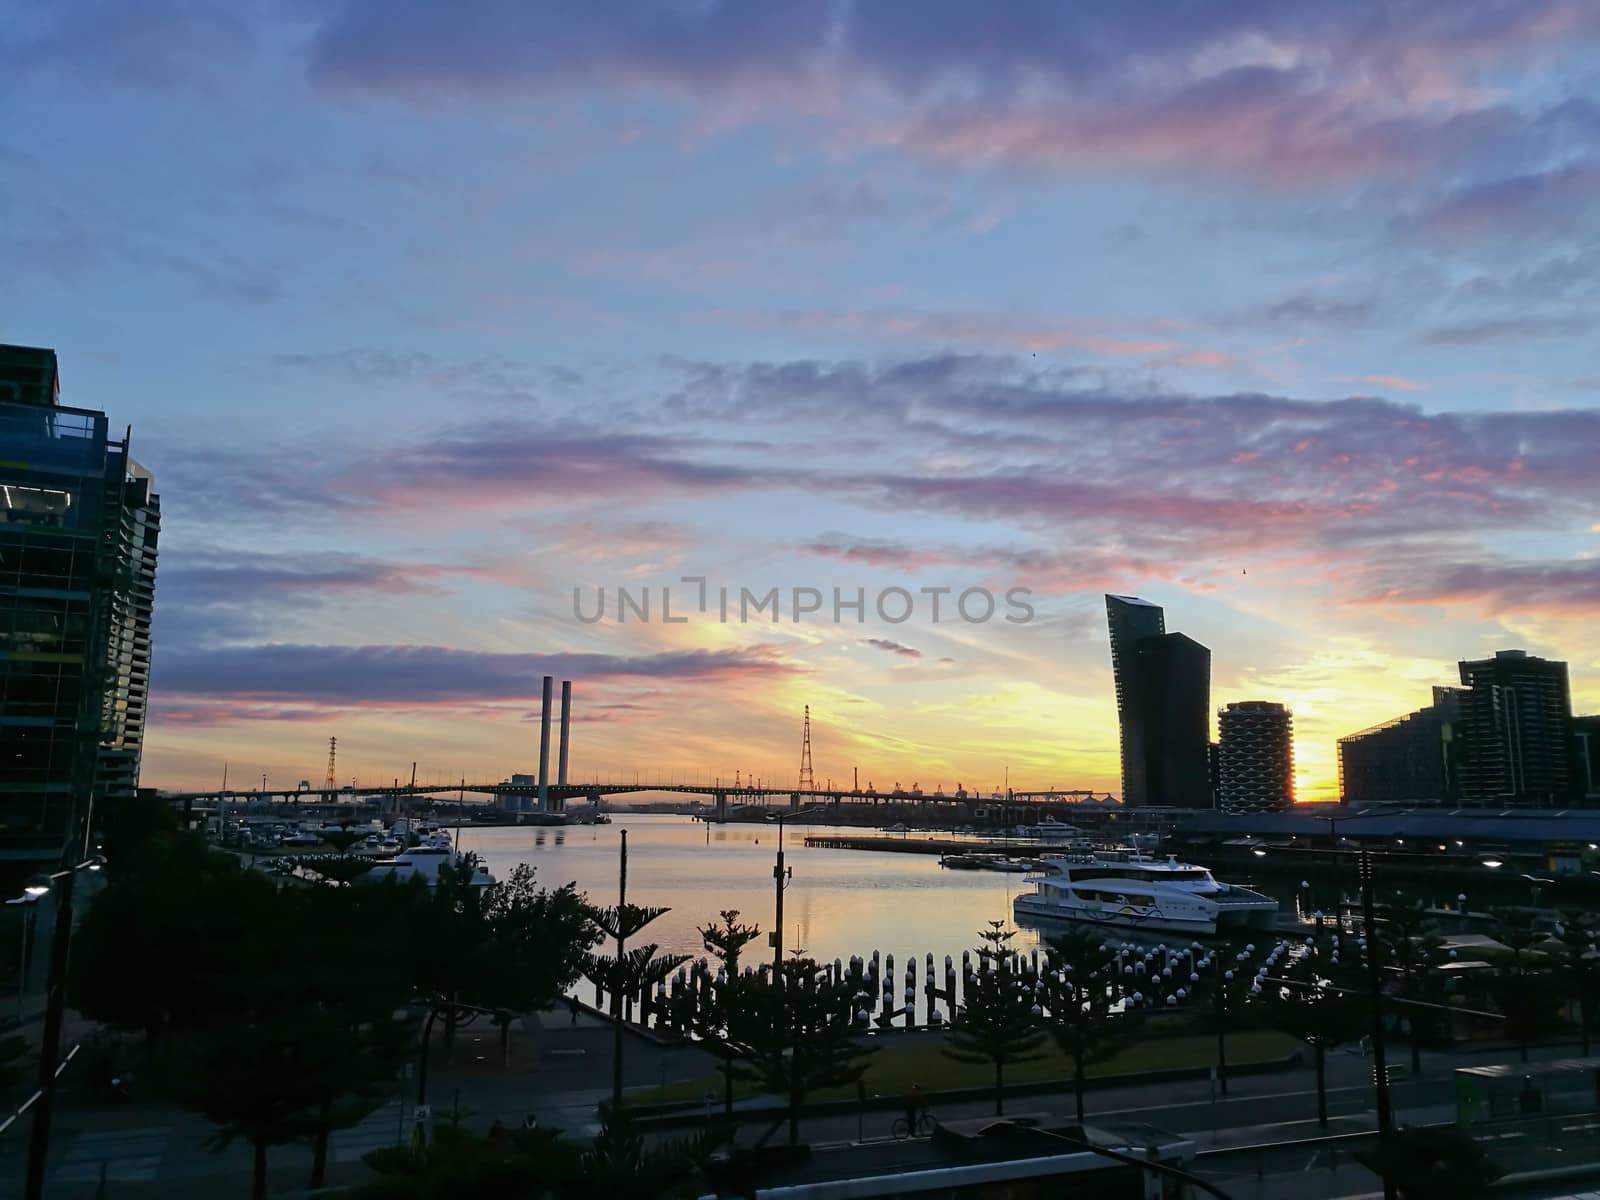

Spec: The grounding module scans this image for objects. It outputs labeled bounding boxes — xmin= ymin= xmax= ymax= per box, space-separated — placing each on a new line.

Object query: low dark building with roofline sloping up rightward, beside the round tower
xmin=1339 ymin=688 xmax=1464 ymax=805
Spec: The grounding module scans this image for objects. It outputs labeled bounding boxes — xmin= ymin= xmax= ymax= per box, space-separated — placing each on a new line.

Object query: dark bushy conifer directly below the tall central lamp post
xmin=734 ymin=955 xmax=872 ymax=1146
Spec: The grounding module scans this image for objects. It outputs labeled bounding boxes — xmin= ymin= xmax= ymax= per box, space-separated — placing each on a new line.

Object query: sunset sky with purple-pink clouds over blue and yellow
xmin=0 ymin=0 xmax=1600 ymax=800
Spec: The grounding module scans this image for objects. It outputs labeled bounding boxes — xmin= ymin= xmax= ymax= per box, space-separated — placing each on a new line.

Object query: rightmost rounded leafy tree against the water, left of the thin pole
xmin=470 ymin=862 xmax=600 ymax=1061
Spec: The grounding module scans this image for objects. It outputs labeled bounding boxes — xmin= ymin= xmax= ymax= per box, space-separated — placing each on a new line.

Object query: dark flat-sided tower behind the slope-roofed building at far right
xmin=1461 ymin=650 xmax=1573 ymax=808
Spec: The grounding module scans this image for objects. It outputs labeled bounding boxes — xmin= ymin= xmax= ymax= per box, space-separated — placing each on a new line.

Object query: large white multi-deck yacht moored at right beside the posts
xmin=1013 ymin=851 xmax=1278 ymax=936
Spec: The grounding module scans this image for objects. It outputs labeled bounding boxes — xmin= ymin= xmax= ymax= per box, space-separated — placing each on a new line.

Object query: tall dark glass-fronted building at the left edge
xmin=0 ymin=346 xmax=160 ymax=859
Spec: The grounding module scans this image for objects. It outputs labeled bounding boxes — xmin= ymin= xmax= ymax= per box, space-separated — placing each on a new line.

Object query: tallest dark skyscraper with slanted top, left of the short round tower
xmin=1106 ymin=595 xmax=1211 ymax=808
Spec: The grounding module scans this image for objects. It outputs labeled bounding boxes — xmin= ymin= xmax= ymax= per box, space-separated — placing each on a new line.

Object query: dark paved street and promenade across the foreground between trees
xmin=0 ymin=1013 xmax=1600 ymax=1200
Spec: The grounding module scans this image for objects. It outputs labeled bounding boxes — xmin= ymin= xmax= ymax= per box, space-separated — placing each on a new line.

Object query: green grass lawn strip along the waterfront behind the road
xmin=629 ymin=1029 xmax=1299 ymax=1104
